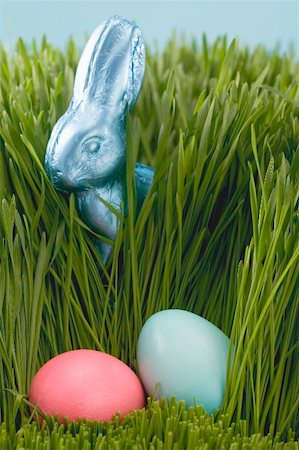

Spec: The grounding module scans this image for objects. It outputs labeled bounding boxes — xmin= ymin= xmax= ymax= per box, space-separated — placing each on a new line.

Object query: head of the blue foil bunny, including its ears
xmin=45 ymin=16 xmax=145 ymax=192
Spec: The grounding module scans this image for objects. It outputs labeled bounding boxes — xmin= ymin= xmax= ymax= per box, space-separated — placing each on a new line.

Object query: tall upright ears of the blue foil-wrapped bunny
xmin=74 ymin=16 xmax=145 ymax=112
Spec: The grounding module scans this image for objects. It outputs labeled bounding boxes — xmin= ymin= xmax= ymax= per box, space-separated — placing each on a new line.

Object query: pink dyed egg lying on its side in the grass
xmin=29 ymin=350 xmax=145 ymax=422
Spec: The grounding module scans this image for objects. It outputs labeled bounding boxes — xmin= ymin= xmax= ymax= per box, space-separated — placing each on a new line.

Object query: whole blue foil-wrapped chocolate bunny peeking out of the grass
xmin=45 ymin=16 xmax=154 ymax=261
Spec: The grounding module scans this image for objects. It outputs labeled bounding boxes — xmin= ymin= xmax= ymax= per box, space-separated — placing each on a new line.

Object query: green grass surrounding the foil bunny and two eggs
xmin=0 ymin=33 xmax=299 ymax=449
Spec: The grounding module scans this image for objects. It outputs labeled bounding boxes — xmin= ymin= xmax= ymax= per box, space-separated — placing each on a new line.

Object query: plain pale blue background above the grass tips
xmin=0 ymin=0 xmax=299 ymax=54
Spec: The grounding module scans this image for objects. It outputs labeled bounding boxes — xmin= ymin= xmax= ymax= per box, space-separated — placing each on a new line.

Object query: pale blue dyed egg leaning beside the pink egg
xmin=137 ymin=309 xmax=229 ymax=413
